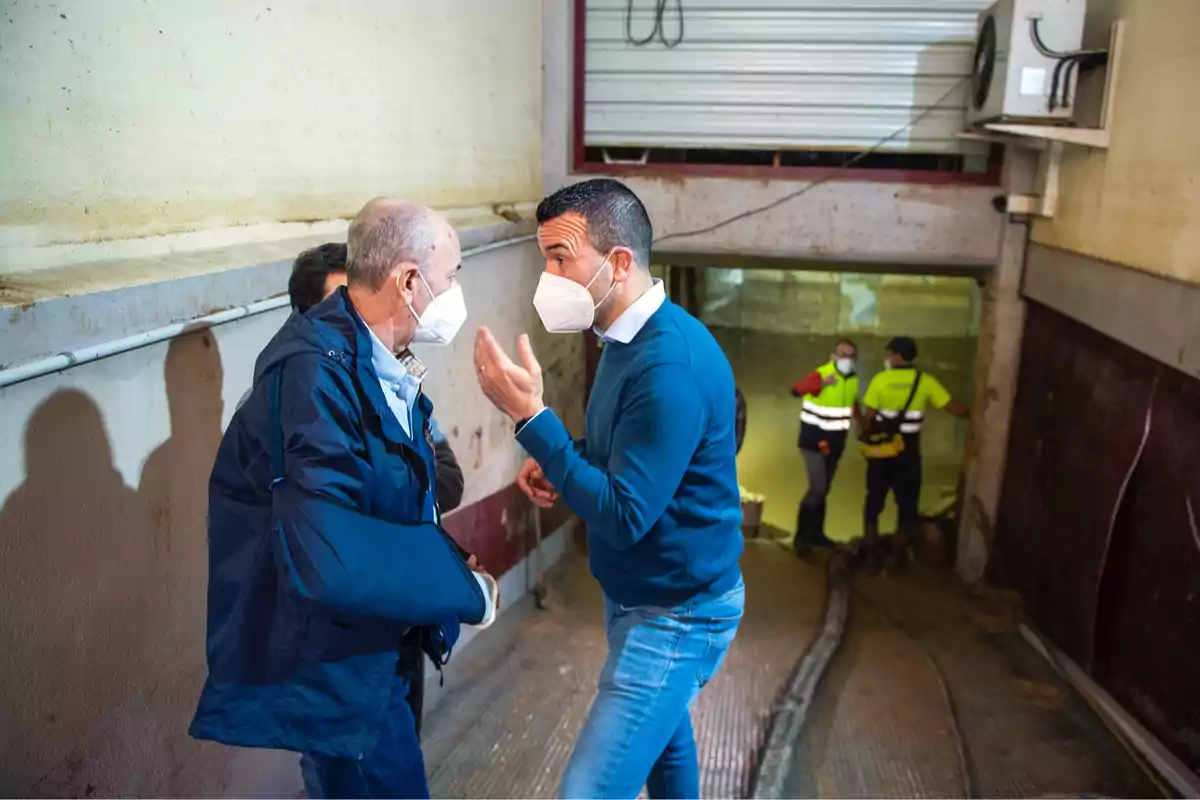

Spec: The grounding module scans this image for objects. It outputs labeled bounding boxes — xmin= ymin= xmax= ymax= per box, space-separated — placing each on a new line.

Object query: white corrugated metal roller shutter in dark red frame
xmin=583 ymin=0 xmax=992 ymax=154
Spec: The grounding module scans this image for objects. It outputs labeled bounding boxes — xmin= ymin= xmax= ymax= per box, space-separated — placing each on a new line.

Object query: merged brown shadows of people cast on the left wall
xmin=0 ymin=332 xmax=294 ymax=796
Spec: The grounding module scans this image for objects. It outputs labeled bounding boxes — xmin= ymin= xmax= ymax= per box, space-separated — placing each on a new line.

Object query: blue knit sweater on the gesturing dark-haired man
xmin=517 ymin=301 xmax=742 ymax=607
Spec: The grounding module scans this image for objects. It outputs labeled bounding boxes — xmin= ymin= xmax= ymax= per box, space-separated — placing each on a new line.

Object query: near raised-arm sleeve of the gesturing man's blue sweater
xmin=517 ymin=363 xmax=708 ymax=549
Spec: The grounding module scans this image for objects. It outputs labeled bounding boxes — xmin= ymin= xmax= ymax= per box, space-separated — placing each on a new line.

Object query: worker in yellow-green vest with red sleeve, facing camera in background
xmin=792 ymin=339 xmax=859 ymax=554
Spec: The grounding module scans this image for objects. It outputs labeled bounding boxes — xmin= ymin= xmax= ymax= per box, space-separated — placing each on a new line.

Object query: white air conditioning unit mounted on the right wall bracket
xmin=967 ymin=0 xmax=1087 ymax=125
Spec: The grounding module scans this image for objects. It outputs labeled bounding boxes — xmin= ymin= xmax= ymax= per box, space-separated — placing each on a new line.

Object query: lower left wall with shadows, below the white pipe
xmin=0 ymin=245 xmax=583 ymax=796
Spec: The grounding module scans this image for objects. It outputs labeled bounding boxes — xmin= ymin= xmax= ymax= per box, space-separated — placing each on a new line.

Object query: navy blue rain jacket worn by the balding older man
xmin=191 ymin=289 xmax=485 ymax=758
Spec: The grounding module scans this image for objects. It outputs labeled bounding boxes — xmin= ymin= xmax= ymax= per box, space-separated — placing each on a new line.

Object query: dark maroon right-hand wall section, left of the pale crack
xmin=995 ymin=303 xmax=1153 ymax=664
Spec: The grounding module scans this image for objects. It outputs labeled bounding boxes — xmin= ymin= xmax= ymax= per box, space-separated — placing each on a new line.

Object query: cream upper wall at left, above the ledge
xmin=0 ymin=0 xmax=541 ymax=256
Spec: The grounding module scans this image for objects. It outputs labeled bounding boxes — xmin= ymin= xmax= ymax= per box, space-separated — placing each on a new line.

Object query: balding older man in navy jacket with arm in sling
xmin=191 ymin=199 xmax=498 ymax=796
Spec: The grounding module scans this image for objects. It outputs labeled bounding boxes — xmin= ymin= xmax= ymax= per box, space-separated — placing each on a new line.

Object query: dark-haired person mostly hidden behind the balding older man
xmin=288 ymin=242 xmax=464 ymax=513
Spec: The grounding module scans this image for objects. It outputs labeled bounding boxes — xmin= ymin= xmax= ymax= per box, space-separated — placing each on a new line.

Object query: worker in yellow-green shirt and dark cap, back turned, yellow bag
xmin=863 ymin=336 xmax=970 ymax=572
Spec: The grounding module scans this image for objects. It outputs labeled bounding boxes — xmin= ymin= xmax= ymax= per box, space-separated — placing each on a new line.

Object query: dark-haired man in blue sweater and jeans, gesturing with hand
xmin=475 ymin=180 xmax=745 ymax=798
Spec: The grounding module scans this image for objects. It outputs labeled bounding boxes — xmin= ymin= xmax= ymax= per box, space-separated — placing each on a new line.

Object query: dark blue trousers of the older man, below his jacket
xmin=300 ymin=675 xmax=430 ymax=800
